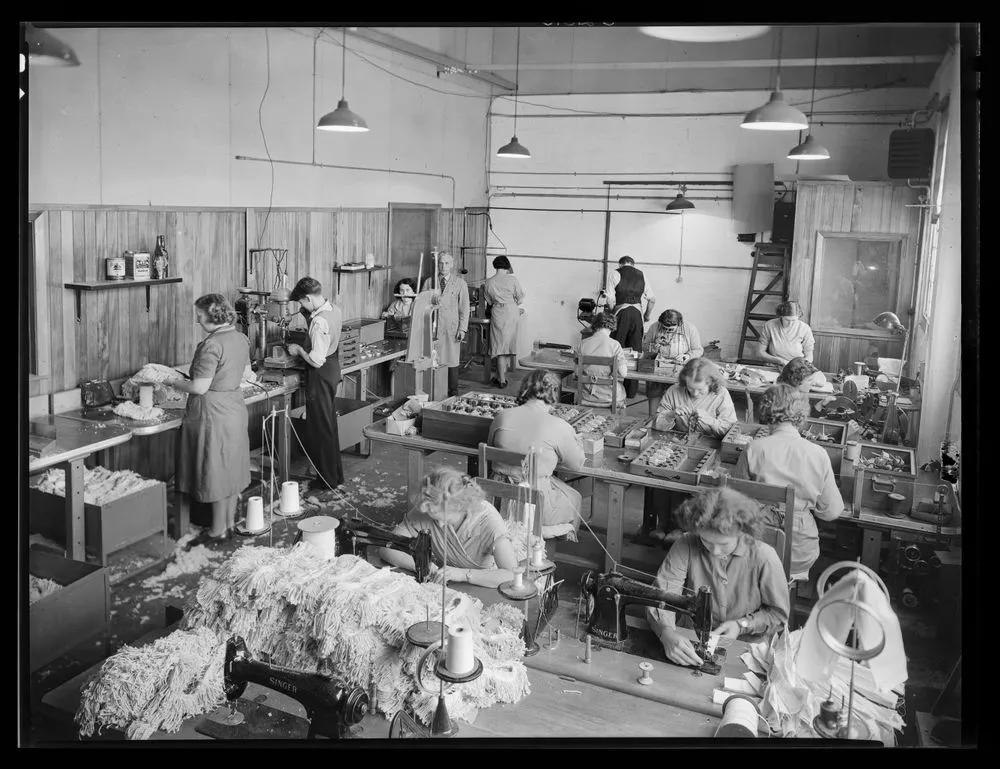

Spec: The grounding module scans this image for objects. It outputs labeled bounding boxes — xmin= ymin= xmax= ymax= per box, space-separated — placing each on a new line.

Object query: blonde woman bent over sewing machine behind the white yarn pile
xmin=380 ymin=467 xmax=517 ymax=587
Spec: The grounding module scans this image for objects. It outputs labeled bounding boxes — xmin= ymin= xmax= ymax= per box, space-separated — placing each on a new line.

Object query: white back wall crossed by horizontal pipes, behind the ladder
xmin=489 ymin=89 xmax=927 ymax=356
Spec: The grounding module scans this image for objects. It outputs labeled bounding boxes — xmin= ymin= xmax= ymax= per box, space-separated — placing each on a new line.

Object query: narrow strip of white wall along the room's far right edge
xmin=913 ymin=46 xmax=962 ymax=463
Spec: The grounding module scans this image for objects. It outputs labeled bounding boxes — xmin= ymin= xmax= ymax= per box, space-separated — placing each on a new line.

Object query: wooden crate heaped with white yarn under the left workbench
xmin=28 ymin=483 xmax=167 ymax=566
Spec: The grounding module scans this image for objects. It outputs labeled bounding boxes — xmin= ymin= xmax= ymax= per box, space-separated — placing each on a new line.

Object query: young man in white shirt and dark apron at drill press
xmin=288 ymin=277 xmax=344 ymax=491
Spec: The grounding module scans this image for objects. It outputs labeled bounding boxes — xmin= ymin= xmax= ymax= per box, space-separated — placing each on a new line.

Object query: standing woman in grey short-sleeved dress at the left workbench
xmin=173 ymin=294 xmax=250 ymax=550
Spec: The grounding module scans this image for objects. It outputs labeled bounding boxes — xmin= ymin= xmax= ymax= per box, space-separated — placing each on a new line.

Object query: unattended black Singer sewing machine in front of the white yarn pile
xmin=223 ymin=636 xmax=370 ymax=740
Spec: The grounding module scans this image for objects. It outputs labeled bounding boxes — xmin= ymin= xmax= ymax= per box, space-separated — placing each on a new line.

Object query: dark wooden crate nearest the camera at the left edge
xmin=28 ymin=550 xmax=111 ymax=670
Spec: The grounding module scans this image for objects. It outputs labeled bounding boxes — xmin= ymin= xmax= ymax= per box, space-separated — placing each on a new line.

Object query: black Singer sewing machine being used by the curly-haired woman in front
xmin=580 ymin=571 xmax=725 ymax=675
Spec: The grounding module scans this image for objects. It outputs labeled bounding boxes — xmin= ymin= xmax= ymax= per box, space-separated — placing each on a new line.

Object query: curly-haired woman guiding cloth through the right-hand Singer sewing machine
xmin=646 ymin=488 xmax=788 ymax=666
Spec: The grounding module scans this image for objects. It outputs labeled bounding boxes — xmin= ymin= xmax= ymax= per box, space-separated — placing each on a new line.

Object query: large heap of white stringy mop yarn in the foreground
xmin=77 ymin=543 xmax=529 ymax=739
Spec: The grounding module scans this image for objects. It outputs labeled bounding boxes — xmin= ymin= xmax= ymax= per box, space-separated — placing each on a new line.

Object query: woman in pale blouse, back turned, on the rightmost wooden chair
xmin=733 ymin=384 xmax=844 ymax=581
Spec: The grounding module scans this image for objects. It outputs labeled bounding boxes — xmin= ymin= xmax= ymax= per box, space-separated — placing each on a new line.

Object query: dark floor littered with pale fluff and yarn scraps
xmin=30 ymin=367 xmax=960 ymax=745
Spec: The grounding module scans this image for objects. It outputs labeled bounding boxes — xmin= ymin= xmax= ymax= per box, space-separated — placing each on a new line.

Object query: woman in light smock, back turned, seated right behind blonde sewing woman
xmin=487 ymin=369 xmax=586 ymax=542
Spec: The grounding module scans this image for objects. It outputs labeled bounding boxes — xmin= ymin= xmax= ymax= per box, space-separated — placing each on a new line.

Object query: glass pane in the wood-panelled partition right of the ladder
xmin=812 ymin=238 xmax=900 ymax=328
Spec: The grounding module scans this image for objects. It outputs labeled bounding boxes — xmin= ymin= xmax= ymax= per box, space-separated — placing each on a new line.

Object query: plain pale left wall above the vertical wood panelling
xmin=28 ymin=28 xmax=489 ymax=207
